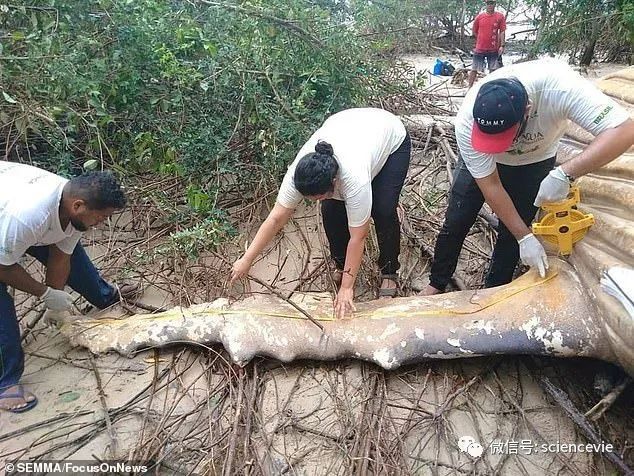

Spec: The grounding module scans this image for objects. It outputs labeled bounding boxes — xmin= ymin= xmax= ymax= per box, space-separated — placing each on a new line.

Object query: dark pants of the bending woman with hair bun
xmin=321 ymin=134 xmax=412 ymax=274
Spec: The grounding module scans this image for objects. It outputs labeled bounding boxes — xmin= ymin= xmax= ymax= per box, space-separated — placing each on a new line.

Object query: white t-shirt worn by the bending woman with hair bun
xmin=277 ymin=108 xmax=406 ymax=227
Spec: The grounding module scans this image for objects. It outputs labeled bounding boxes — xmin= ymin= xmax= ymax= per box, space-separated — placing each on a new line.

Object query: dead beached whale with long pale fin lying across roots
xmin=56 ymin=67 xmax=634 ymax=375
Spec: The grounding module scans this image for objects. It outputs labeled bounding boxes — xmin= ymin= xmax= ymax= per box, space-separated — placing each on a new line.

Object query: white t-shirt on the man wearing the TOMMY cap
xmin=456 ymin=59 xmax=629 ymax=178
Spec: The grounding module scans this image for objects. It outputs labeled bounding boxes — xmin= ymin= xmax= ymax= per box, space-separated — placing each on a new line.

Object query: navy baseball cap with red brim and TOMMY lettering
xmin=471 ymin=78 xmax=528 ymax=154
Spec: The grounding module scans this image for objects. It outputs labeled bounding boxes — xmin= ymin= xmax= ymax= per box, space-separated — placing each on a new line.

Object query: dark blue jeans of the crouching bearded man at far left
xmin=0 ymin=244 xmax=119 ymax=393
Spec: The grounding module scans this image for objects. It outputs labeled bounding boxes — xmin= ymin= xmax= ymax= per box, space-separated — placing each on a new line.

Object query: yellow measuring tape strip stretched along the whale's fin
xmin=84 ymin=270 xmax=559 ymax=325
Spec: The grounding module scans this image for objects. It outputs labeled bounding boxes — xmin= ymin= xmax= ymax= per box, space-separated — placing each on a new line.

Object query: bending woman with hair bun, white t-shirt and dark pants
xmin=231 ymin=108 xmax=411 ymax=318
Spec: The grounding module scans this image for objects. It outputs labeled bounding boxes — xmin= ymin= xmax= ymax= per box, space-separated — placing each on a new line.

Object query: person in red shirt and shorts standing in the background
xmin=469 ymin=0 xmax=506 ymax=87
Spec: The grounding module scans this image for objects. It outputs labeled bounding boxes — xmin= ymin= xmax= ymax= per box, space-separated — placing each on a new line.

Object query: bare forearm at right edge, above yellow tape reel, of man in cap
xmin=561 ymin=119 xmax=634 ymax=178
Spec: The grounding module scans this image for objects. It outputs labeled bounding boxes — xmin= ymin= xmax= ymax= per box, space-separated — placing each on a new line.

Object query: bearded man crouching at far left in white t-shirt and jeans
xmin=0 ymin=161 xmax=126 ymax=413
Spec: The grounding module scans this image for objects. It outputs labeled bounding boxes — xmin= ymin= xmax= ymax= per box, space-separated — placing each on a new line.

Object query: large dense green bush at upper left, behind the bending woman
xmin=0 ymin=0 xmax=420 ymax=253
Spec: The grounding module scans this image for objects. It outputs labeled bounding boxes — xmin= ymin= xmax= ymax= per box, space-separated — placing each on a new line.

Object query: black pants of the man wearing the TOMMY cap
xmin=429 ymin=157 xmax=555 ymax=291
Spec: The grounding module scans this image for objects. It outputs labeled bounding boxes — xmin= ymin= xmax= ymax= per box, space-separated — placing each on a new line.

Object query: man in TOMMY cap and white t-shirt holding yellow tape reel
xmin=424 ymin=60 xmax=634 ymax=295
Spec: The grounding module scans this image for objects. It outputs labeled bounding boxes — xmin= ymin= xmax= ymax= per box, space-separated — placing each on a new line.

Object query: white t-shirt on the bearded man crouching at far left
xmin=0 ymin=160 xmax=81 ymax=266
